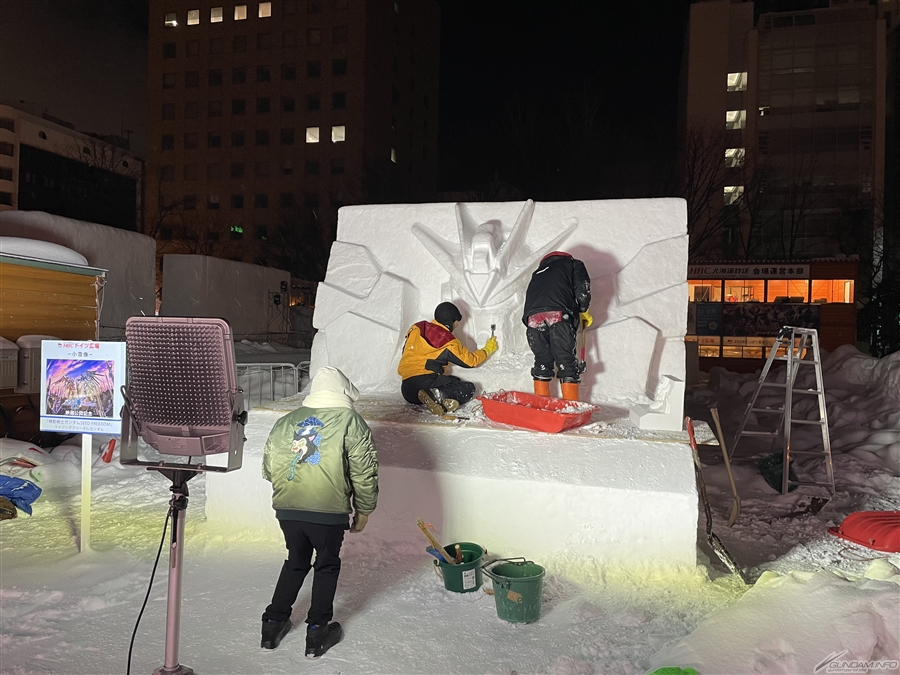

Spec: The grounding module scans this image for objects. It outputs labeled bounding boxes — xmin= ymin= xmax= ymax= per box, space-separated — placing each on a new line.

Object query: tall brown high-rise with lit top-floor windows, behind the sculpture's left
xmin=146 ymin=0 xmax=440 ymax=279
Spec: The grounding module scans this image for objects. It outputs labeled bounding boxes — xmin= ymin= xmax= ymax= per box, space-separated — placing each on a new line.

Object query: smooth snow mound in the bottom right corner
xmin=663 ymin=556 xmax=900 ymax=673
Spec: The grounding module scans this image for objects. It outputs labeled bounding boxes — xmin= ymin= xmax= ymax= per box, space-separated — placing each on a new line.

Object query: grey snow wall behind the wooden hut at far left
xmin=0 ymin=211 xmax=156 ymax=340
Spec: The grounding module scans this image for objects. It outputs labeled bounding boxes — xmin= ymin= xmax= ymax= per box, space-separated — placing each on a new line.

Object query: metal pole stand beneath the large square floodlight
xmin=153 ymin=468 xmax=197 ymax=675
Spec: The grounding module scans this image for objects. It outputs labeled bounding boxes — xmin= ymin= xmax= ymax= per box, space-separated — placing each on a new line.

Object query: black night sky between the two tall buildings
xmin=438 ymin=0 xmax=689 ymax=196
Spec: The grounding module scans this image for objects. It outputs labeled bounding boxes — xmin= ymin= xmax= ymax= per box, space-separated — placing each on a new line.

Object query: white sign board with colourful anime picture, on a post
xmin=41 ymin=340 xmax=125 ymax=551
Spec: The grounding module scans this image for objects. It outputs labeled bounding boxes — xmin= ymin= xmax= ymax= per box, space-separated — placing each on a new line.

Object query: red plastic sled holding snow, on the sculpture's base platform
xmin=478 ymin=391 xmax=597 ymax=434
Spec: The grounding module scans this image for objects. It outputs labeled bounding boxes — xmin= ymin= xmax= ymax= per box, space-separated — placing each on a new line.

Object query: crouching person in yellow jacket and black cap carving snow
xmin=397 ymin=302 xmax=497 ymax=415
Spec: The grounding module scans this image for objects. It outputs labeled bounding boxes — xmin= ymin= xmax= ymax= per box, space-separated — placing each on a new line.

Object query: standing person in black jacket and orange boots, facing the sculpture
xmin=522 ymin=251 xmax=593 ymax=401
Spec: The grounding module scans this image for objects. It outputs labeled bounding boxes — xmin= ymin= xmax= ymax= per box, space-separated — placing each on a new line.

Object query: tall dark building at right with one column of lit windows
xmin=681 ymin=0 xmax=900 ymax=262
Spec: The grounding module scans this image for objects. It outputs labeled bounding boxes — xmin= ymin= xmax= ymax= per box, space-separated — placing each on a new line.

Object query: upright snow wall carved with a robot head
xmin=310 ymin=199 xmax=688 ymax=403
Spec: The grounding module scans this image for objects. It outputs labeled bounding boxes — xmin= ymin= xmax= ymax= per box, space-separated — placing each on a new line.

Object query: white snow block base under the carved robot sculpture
xmin=206 ymin=401 xmax=698 ymax=567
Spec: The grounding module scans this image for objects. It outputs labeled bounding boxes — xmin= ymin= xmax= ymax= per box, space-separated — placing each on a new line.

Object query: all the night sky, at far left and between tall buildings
xmin=0 ymin=0 xmax=689 ymax=198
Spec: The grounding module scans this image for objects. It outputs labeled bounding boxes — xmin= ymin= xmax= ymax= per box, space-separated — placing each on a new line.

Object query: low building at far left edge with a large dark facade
xmin=0 ymin=103 xmax=143 ymax=230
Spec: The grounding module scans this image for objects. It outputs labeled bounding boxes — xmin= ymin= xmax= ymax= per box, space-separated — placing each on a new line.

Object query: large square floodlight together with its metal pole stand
xmin=119 ymin=316 xmax=247 ymax=675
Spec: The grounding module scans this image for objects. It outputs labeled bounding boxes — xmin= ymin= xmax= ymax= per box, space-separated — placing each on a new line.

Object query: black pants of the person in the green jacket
xmin=262 ymin=520 xmax=347 ymax=625
